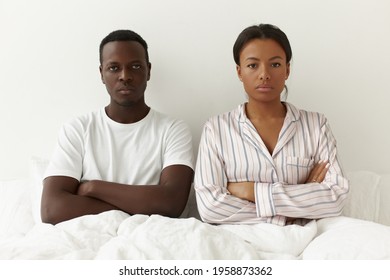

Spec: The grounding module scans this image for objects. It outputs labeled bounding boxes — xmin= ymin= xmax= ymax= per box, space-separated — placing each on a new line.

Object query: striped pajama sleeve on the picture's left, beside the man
xmin=194 ymin=123 xmax=284 ymax=224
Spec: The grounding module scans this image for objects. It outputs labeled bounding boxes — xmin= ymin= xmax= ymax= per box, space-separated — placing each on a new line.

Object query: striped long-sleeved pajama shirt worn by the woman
xmin=194 ymin=102 xmax=349 ymax=225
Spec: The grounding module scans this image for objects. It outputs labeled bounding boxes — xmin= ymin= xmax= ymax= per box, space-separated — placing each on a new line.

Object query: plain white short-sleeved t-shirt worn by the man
xmin=45 ymin=108 xmax=194 ymax=185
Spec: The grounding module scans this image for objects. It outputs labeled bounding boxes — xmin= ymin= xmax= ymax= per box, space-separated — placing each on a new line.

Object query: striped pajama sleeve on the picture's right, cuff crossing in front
xmin=255 ymin=117 xmax=349 ymax=219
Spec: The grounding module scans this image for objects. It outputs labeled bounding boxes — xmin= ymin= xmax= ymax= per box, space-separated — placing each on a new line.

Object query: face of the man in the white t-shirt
xmin=100 ymin=41 xmax=151 ymax=107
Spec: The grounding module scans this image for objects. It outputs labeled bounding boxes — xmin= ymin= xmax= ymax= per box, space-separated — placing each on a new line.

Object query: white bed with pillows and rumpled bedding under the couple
xmin=0 ymin=157 xmax=390 ymax=260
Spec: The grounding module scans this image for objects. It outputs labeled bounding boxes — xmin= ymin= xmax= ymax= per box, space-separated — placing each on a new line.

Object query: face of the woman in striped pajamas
xmin=237 ymin=39 xmax=290 ymax=103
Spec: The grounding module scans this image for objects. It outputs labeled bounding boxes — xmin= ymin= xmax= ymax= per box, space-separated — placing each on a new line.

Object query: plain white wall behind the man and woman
xmin=0 ymin=0 xmax=390 ymax=180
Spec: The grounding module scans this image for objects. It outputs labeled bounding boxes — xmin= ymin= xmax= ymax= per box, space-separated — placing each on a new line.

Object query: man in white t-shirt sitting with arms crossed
xmin=41 ymin=30 xmax=193 ymax=224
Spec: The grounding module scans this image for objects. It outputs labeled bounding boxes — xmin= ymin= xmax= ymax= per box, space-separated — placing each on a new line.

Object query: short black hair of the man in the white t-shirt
xmin=99 ymin=29 xmax=149 ymax=64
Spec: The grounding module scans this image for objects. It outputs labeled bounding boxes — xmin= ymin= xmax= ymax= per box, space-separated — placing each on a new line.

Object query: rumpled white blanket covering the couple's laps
xmin=0 ymin=211 xmax=317 ymax=260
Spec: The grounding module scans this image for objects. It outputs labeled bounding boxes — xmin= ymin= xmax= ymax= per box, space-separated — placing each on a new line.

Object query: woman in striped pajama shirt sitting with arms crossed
xmin=194 ymin=24 xmax=349 ymax=225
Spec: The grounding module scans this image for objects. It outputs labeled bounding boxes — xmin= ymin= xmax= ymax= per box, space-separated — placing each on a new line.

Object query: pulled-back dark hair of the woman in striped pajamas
xmin=233 ymin=24 xmax=292 ymax=65
